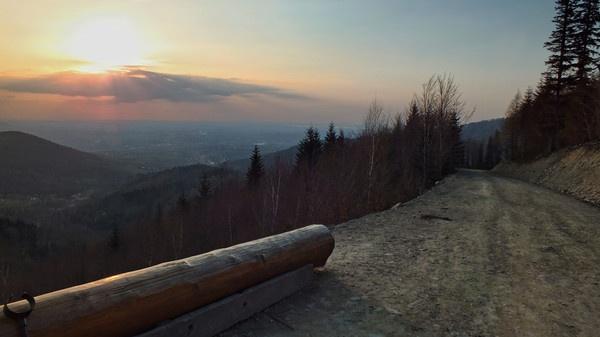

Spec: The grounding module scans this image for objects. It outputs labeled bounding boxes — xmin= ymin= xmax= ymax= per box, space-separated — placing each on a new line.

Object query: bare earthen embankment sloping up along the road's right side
xmin=493 ymin=143 xmax=600 ymax=206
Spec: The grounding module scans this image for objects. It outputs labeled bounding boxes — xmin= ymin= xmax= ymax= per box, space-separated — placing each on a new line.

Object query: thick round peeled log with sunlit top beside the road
xmin=0 ymin=225 xmax=334 ymax=337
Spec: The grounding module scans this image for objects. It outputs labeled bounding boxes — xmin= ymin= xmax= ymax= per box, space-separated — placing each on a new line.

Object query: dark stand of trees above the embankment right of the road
xmin=502 ymin=0 xmax=600 ymax=161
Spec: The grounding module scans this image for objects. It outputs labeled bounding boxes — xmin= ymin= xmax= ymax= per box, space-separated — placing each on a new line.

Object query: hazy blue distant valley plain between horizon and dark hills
xmin=0 ymin=121 xmax=326 ymax=173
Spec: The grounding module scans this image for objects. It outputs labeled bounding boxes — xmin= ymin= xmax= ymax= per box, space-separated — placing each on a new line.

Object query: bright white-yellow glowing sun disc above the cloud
xmin=65 ymin=17 xmax=148 ymax=72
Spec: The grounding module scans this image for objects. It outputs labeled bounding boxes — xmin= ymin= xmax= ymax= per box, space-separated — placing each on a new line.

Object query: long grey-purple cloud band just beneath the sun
xmin=0 ymin=67 xmax=307 ymax=102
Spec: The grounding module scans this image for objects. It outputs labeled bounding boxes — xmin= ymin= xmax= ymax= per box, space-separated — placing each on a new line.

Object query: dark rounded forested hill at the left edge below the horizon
xmin=0 ymin=131 xmax=133 ymax=196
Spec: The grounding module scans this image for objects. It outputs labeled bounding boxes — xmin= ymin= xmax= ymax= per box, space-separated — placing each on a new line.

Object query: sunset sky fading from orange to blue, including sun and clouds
xmin=0 ymin=0 xmax=553 ymax=123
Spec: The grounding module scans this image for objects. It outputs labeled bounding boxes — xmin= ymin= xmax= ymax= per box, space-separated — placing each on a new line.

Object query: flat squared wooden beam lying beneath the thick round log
xmin=136 ymin=265 xmax=314 ymax=337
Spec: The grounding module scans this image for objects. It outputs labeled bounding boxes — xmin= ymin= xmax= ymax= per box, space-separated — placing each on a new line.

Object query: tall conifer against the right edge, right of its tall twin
xmin=575 ymin=0 xmax=600 ymax=86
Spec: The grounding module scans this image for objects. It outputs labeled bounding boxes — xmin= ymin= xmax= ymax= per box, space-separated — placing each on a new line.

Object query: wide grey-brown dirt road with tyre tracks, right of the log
xmin=223 ymin=171 xmax=600 ymax=337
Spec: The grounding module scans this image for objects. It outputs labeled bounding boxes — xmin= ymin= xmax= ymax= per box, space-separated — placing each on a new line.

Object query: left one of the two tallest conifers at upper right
xmin=544 ymin=0 xmax=577 ymax=94
